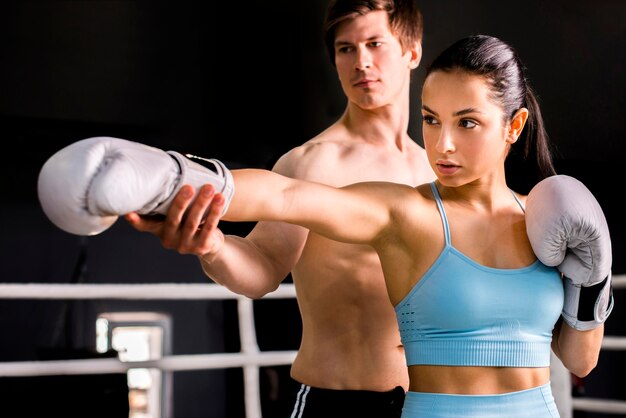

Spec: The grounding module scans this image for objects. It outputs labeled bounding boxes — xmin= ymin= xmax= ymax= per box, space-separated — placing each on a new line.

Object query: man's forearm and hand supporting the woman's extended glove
xmin=126 ymin=183 xmax=308 ymax=298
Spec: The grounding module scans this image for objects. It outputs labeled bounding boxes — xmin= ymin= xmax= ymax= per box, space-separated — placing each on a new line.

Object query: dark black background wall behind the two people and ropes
xmin=0 ymin=0 xmax=626 ymax=418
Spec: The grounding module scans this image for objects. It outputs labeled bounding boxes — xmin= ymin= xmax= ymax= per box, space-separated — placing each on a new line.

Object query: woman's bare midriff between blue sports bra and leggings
xmin=409 ymin=365 xmax=550 ymax=395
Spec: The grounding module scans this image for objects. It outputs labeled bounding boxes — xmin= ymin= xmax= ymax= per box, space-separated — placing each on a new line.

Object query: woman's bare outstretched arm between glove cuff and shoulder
xmin=223 ymin=169 xmax=406 ymax=244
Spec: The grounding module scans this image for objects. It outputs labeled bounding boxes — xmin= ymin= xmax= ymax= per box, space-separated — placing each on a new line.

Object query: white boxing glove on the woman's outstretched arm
xmin=37 ymin=137 xmax=234 ymax=236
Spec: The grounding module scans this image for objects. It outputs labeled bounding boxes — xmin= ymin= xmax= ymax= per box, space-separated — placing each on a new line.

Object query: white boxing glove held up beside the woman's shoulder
xmin=526 ymin=175 xmax=613 ymax=331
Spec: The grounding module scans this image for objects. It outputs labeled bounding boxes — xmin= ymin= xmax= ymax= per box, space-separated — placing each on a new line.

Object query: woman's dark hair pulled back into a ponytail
xmin=426 ymin=35 xmax=556 ymax=180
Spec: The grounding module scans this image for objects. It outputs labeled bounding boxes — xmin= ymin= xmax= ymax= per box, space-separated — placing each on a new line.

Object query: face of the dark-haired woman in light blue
xmin=422 ymin=70 xmax=511 ymax=186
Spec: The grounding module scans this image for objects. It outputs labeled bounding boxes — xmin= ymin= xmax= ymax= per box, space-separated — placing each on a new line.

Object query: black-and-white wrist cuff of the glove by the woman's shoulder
xmin=563 ymin=273 xmax=614 ymax=331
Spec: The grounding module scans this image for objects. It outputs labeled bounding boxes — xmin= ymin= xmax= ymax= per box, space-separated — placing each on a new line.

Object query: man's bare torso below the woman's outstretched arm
xmin=291 ymin=234 xmax=408 ymax=391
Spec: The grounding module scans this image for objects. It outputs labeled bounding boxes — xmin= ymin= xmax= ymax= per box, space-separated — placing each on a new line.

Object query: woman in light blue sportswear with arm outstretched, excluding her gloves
xmin=133 ymin=35 xmax=603 ymax=418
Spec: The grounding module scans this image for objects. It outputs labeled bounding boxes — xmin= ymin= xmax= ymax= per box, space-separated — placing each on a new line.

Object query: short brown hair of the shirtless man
xmin=324 ymin=0 xmax=423 ymax=66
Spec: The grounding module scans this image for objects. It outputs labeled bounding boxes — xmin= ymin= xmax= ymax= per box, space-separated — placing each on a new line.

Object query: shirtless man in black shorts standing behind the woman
xmin=126 ymin=0 xmax=435 ymax=418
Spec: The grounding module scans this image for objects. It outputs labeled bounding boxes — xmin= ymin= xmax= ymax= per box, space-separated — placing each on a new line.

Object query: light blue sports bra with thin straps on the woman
xmin=395 ymin=183 xmax=563 ymax=367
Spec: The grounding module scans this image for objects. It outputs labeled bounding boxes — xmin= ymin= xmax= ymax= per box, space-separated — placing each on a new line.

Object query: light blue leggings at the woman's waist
xmin=402 ymin=383 xmax=559 ymax=418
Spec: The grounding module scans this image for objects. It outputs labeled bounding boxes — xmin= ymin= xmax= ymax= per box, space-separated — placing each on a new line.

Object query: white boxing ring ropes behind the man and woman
xmin=0 ymin=275 xmax=626 ymax=418
